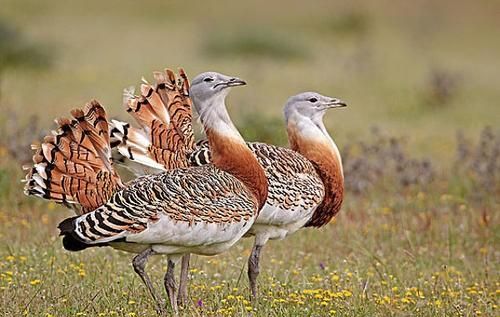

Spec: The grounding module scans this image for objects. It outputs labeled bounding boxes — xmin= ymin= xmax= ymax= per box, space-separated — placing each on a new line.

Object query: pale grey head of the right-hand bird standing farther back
xmin=284 ymin=92 xmax=347 ymax=121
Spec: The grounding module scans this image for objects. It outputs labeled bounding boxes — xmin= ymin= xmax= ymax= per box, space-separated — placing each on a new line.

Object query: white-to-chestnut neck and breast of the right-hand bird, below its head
xmin=287 ymin=115 xmax=344 ymax=227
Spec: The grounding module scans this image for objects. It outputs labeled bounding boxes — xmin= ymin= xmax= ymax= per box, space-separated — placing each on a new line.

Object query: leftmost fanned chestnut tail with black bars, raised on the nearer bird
xmin=25 ymin=101 xmax=123 ymax=213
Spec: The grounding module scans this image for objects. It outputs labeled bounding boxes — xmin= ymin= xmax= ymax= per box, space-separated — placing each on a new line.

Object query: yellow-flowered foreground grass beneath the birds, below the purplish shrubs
xmin=0 ymin=144 xmax=500 ymax=316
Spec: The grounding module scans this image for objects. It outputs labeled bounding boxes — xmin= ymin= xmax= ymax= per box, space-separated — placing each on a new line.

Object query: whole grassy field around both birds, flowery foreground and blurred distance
xmin=0 ymin=0 xmax=500 ymax=316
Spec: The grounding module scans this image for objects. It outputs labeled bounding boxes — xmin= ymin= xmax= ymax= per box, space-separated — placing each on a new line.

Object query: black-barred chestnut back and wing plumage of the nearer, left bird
xmin=70 ymin=165 xmax=257 ymax=243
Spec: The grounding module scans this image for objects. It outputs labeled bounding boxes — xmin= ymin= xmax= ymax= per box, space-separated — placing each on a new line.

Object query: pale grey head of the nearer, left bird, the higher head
xmin=190 ymin=72 xmax=246 ymax=113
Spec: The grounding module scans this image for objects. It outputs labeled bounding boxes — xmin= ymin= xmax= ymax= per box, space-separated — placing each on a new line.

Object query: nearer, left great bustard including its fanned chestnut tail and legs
xmin=22 ymin=73 xmax=268 ymax=310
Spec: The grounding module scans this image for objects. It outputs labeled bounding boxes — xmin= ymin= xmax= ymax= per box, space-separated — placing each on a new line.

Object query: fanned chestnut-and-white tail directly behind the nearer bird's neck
xmin=111 ymin=69 xmax=195 ymax=174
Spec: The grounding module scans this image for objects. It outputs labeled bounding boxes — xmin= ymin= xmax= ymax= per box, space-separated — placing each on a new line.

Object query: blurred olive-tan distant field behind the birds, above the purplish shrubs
xmin=0 ymin=0 xmax=500 ymax=160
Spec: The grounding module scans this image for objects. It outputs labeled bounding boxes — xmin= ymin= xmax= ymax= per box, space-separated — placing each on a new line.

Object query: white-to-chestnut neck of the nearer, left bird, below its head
xmin=200 ymin=99 xmax=268 ymax=210
